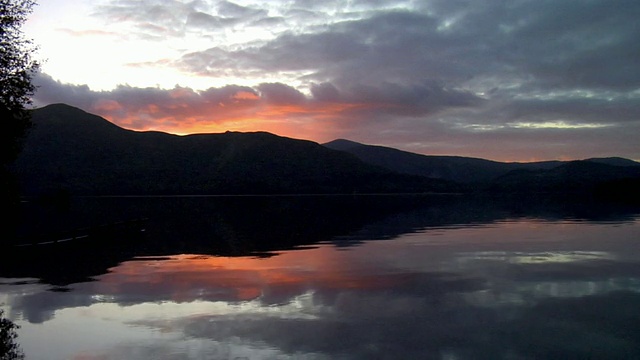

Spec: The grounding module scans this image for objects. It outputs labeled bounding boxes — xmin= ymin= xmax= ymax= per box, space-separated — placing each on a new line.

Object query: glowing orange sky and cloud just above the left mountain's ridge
xmin=91 ymin=89 xmax=402 ymax=143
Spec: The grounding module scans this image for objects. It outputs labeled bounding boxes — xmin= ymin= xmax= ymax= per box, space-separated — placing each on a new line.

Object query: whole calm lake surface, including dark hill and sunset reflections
xmin=0 ymin=196 xmax=640 ymax=360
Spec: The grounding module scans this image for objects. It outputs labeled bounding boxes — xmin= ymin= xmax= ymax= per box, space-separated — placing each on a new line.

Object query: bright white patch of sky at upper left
xmin=25 ymin=0 xmax=420 ymax=91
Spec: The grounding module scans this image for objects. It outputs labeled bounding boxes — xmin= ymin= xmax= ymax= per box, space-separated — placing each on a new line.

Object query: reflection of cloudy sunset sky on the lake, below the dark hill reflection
xmin=0 ymin=197 xmax=640 ymax=359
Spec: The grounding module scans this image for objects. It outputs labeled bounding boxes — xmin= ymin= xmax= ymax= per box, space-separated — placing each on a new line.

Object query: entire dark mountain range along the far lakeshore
xmin=14 ymin=104 xmax=640 ymax=196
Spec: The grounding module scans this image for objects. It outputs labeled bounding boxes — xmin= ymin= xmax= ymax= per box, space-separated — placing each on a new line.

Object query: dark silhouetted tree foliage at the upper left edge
xmin=0 ymin=0 xmax=40 ymax=166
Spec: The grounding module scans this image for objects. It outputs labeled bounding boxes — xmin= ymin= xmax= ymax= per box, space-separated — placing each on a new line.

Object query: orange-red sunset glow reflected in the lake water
xmin=98 ymin=245 xmax=420 ymax=303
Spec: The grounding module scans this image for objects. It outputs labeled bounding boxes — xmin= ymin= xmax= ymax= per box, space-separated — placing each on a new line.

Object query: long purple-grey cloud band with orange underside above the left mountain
xmin=30 ymin=74 xmax=481 ymax=141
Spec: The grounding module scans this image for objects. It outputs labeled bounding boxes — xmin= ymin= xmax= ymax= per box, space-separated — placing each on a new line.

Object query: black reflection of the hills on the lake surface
xmin=0 ymin=195 xmax=640 ymax=285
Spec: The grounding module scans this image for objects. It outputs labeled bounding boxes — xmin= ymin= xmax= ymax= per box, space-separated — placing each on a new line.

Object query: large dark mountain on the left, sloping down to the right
xmin=14 ymin=104 xmax=456 ymax=195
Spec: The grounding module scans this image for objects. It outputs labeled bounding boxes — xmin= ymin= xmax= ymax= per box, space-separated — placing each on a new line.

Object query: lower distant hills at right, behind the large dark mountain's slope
xmin=323 ymin=139 xmax=640 ymax=197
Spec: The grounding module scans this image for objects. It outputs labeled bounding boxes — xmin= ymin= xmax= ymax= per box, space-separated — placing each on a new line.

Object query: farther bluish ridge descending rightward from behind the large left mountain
xmin=323 ymin=139 xmax=561 ymax=184
